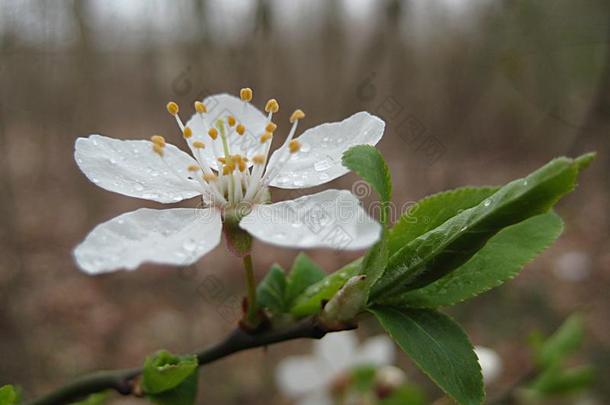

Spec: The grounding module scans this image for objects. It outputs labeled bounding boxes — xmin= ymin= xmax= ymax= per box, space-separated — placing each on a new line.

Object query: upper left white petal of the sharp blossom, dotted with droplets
xmin=74 ymin=135 xmax=201 ymax=203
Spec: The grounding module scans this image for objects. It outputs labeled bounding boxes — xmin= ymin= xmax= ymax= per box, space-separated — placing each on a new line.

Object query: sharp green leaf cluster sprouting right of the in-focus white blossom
xmin=258 ymin=145 xmax=594 ymax=404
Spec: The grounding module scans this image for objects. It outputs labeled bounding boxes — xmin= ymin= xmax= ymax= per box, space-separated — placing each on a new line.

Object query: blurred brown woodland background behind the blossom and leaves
xmin=0 ymin=0 xmax=610 ymax=404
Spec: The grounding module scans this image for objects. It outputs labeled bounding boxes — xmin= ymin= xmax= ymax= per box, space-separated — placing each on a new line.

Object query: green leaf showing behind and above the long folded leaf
xmin=389 ymin=187 xmax=498 ymax=255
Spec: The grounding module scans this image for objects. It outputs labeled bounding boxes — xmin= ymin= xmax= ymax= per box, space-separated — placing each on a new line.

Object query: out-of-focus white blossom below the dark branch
xmin=275 ymin=331 xmax=394 ymax=405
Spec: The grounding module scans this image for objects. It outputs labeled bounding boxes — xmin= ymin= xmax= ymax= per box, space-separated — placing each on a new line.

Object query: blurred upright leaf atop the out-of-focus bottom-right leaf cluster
xmin=536 ymin=314 xmax=584 ymax=367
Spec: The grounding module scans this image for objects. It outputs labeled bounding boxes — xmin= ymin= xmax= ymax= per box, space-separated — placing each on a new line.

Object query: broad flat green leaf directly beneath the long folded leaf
xmin=388 ymin=212 xmax=563 ymax=308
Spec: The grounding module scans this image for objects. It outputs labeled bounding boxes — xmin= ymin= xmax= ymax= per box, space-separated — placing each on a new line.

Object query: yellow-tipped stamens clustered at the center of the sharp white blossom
xmin=150 ymin=88 xmax=305 ymax=215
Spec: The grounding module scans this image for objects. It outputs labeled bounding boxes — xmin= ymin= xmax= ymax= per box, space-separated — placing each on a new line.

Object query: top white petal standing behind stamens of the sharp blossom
xmin=186 ymin=94 xmax=267 ymax=168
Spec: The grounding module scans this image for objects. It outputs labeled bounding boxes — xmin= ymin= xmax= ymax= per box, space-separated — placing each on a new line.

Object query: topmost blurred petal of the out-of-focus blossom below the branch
xmin=314 ymin=331 xmax=358 ymax=375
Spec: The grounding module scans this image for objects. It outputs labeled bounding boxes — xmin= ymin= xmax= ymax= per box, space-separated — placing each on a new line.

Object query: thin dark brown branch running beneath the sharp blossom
xmin=29 ymin=317 xmax=342 ymax=405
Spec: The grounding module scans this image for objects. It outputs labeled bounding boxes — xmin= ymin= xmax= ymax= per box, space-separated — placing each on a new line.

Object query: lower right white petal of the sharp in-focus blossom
xmin=239 ymin=190 xmax=381 ymax=250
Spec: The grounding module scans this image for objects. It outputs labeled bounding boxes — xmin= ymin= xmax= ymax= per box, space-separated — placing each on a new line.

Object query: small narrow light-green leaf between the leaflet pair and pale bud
xmin=290 ymin=258 xmax=362 ymax=318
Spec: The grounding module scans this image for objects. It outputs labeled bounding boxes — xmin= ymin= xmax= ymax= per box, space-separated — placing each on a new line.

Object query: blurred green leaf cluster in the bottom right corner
xmin=523 ymin=315 xmax=595 ymax=402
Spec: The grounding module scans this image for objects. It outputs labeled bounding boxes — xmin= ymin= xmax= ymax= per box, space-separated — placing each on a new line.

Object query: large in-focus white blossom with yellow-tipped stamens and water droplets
xmin=74 ymin=89 xmax=384 ymax=274
